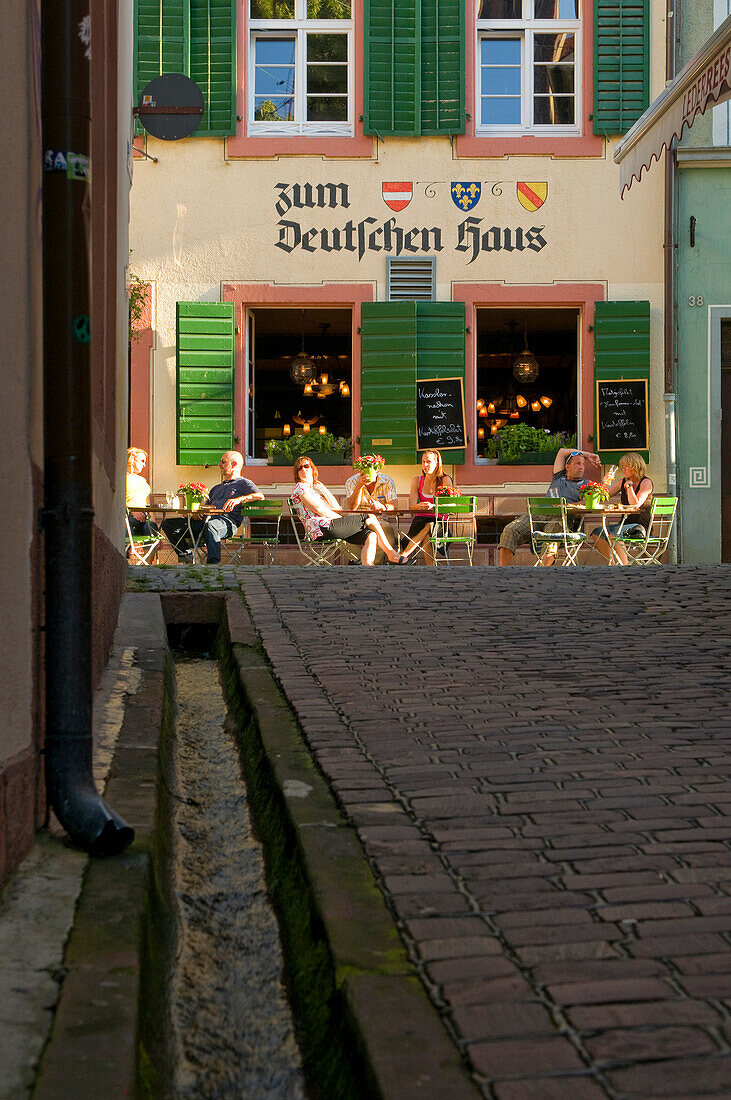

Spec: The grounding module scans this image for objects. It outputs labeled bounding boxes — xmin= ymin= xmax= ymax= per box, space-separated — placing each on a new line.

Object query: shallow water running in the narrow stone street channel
xmin=171 ymin=657 xmax=304 ymax=1100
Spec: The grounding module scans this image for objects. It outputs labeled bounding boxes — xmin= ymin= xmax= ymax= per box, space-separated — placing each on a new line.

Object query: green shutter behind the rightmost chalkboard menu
xmin=594 ymin=301 xmax=650 ymax=462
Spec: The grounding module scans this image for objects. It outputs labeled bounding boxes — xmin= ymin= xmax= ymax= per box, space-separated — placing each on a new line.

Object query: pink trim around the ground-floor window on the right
xmin=452 ymin=283 xmax=607 ymax=484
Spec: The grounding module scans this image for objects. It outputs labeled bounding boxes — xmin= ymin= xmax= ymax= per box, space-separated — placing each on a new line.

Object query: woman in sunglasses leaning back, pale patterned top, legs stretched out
xmin=291 ymin=455 xmax=401 ymax=565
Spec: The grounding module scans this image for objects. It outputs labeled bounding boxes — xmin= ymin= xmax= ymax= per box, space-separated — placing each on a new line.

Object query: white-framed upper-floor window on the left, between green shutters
xmin=248 ymin=0 xmax=353 ymax=134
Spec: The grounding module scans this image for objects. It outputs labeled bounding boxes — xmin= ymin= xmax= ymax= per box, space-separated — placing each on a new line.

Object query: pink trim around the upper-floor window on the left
xmin=226 ymin=0 xmax=374 ymax=158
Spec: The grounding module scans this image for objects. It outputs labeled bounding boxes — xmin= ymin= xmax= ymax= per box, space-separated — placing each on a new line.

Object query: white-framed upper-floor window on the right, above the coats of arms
xmin=475 ymin=0 xmax=582 ymax=134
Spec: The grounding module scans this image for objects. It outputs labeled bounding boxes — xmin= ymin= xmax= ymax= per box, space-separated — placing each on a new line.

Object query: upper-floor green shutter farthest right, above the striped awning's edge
xmin=594 ymin=0 xmax=650 ymax=135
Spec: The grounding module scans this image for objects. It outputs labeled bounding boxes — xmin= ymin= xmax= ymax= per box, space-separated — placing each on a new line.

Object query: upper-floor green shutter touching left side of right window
xmin=421 ymin=0 xmax=466 ymax=135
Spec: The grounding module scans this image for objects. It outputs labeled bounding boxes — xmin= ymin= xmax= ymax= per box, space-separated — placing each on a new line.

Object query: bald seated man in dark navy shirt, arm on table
xmin=163 ymin=451 xmax=264 ymax=565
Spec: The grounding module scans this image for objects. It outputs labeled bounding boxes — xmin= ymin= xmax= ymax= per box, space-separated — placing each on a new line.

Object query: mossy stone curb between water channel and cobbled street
xmin=225 ymin=595 xmax=480 ymax=1100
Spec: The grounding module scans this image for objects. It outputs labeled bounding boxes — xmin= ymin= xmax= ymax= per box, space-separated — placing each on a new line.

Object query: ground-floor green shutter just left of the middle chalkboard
xmin=361 ymin=301 xmax=421 ymax=465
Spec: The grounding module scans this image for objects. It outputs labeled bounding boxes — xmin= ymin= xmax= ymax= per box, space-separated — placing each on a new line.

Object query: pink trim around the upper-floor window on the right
xmin=456 ymin=0 xmax=605 ymax=157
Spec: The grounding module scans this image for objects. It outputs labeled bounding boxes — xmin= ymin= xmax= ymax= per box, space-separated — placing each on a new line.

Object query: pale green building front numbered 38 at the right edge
xmin=672 ymin=0 xmax=731 ymax=562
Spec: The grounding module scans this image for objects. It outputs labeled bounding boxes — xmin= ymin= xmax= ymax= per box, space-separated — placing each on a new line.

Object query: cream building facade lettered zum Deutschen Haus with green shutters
xmin=131 ymin=0 xmax=665 ymax=503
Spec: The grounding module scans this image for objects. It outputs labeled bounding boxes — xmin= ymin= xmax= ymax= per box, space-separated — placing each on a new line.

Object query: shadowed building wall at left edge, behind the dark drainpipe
xmin=0 ymin=2 xmax=132 ymax=881
